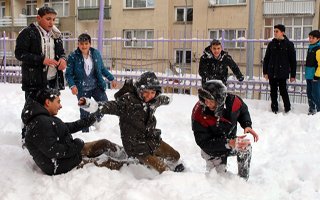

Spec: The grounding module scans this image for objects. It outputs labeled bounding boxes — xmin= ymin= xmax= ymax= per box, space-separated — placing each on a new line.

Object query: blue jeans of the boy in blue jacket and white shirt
xmin=77 ymin=87 xmax=108 ymax=132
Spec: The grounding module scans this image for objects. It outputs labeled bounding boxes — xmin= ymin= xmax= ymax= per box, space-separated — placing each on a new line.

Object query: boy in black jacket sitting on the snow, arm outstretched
xmin=21 ymin=88 xmax=123 ymax=175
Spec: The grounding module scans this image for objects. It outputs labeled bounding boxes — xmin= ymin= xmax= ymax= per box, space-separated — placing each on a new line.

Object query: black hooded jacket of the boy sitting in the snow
xmin=21 ymin=100 xmax=95 ymax=175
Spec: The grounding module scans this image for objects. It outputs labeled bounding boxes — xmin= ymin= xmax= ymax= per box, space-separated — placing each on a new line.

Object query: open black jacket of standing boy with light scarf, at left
xmin=15 ymin=24 xmax=66 ymax=91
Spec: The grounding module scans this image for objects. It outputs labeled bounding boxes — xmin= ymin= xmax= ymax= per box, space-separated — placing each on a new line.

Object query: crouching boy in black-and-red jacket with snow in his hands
xmin=192 ymin=80 xmax=259 ymax=180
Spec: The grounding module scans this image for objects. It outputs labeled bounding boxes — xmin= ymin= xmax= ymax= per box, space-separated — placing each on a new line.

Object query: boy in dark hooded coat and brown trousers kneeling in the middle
xmin=79 ymin=72 xmax=184 ymax=173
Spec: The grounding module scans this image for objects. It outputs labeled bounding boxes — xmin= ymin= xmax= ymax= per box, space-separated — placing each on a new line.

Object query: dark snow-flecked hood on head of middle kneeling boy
xmin=135 ymin=72 xmax=161 ymax=95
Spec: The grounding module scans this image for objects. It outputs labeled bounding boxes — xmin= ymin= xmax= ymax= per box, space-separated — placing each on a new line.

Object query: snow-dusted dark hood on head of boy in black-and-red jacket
xmin=198 ymin=80 xmax=227 ymax=107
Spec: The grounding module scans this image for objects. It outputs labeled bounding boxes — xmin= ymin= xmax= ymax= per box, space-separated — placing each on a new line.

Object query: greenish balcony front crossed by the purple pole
xmin=78 ymin=6 xmax=111 ymax=20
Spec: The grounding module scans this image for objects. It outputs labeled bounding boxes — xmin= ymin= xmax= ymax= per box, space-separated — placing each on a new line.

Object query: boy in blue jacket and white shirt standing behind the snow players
xmin=66 ymin=33 xmax=117 ymax=132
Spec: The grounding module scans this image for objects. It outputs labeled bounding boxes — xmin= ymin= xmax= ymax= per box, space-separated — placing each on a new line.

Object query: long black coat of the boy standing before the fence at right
xmin=263 ymin=37 xmax=297 ymax=79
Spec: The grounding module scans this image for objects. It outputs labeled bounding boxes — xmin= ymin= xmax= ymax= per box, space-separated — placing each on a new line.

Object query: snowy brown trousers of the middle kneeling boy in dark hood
xmin=138 ymin=141 xmax=180 ymax=173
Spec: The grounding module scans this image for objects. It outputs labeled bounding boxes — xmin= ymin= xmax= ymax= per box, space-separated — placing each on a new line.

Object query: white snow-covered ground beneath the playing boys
xmin=0 ymin=83 xmax=320 ymax=200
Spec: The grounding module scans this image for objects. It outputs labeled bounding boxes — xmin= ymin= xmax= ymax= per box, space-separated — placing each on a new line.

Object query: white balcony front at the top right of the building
xmin=263 ymin=0 xmax=315 ymax=16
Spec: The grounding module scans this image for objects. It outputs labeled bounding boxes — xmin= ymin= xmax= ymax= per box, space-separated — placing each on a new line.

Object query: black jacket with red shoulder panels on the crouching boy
xmin=192 ymin=94 xmax=252 ymax=156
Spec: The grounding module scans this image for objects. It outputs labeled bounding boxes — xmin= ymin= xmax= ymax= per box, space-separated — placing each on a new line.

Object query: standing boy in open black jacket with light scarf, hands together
xmin=15 ymin=6 xmax=67 ymax=99
